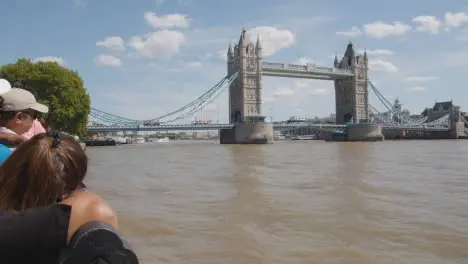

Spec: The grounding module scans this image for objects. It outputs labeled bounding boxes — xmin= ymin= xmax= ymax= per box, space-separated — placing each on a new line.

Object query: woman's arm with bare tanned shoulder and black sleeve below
xmin=57 ymin=190 xmax=139 ymax=264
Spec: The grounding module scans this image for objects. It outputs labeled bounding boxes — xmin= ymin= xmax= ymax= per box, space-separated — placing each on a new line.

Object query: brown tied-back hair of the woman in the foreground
xmin=0 ymin=132 xmax=88 ymax=212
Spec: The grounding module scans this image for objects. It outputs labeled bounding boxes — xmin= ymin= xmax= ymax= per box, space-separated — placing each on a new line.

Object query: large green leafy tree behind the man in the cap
xmin=0 ymin=59 xmax=91 ymax=136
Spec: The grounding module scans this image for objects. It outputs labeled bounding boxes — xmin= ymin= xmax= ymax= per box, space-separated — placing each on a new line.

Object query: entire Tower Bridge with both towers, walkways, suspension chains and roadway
xmin=88 ymin=27 xmax=460 ymax=143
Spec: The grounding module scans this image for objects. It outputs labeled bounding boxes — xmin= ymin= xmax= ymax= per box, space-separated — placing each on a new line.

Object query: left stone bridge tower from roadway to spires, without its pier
xmin=227 ymin=26 xmax=264 ymax=124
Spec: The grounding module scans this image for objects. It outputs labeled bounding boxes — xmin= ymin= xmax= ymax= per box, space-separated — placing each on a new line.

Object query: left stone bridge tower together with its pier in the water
xmin=219 ymin=26 xmax=274 ymax=144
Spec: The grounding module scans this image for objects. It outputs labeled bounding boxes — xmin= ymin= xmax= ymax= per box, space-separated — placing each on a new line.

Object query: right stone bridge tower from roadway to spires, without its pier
xmin=334 ymin=41 xmax=369 ymax=124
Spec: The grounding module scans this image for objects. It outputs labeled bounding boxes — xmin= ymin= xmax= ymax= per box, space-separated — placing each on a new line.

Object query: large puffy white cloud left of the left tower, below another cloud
xmin=128 ymin=30 xmax=185 ymax=59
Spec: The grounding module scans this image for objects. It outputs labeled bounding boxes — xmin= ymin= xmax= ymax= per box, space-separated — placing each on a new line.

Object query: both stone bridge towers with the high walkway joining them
xmin=226 ymin=27 xmax=369 ymax=128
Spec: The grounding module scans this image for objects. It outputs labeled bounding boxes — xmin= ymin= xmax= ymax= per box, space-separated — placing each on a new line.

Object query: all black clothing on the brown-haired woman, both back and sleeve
xmin=0 ymin=184 xmax=138 ymax=264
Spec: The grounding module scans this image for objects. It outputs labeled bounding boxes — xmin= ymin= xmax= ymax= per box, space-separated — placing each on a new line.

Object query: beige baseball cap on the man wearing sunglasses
xmin=0 ymin=88 xmax=49 ymax=114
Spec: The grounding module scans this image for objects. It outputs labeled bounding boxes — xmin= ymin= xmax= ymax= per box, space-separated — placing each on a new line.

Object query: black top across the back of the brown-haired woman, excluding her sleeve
xmin=0 ymin=204 xmax=71 ymax=264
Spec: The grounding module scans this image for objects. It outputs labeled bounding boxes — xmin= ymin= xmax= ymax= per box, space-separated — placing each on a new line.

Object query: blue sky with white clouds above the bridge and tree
xmin=0 ymin=0 xmax=468 ymax=121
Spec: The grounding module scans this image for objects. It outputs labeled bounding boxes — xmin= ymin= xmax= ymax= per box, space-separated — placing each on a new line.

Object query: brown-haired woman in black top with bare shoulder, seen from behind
xmin=0 ymin=132 xmax=138 ymax=264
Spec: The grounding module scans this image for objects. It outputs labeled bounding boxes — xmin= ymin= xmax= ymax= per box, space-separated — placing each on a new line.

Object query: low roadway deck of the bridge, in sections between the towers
xmin=88 ymin=123 xmax=449 ymax=132
